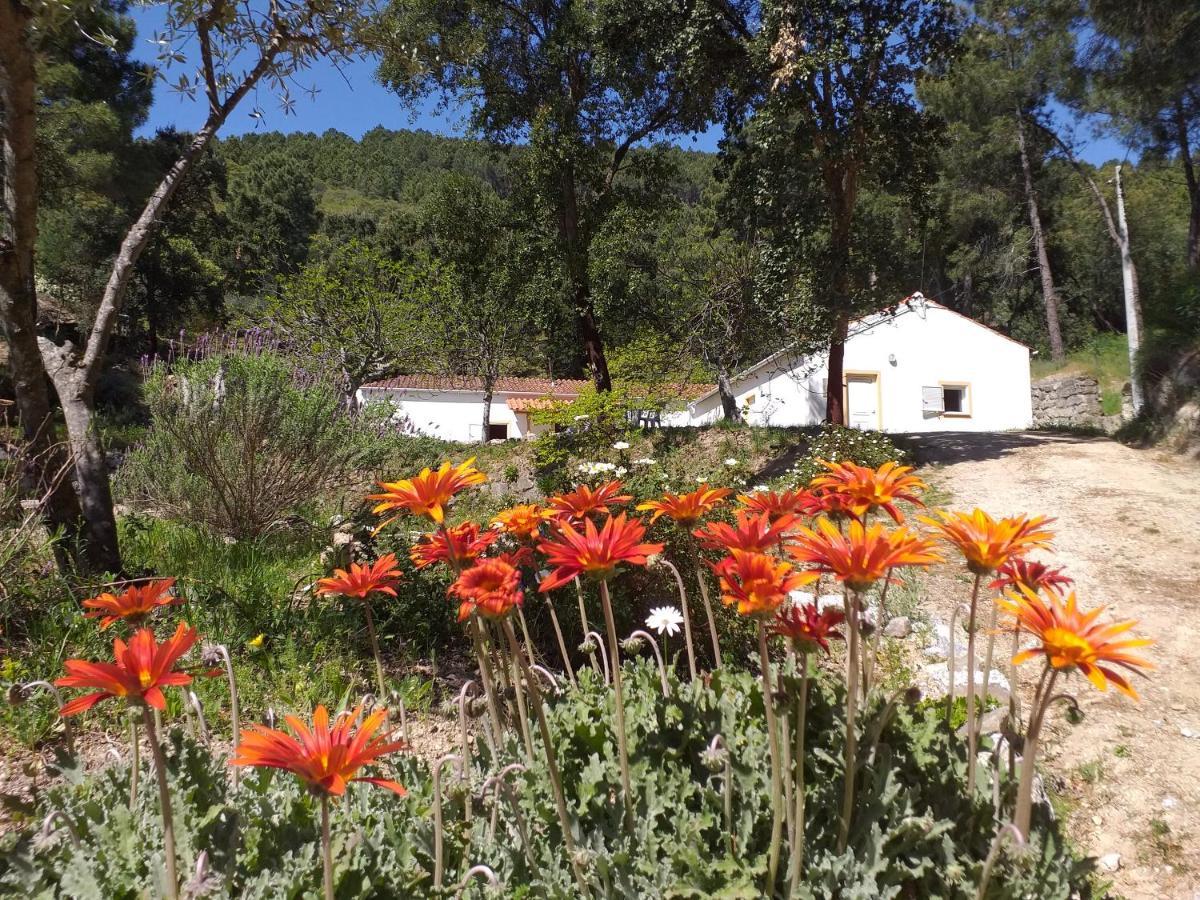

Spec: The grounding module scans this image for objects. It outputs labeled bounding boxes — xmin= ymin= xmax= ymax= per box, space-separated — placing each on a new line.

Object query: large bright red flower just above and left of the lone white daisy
xmin=538 ymin=512 xmax=662 ymax=593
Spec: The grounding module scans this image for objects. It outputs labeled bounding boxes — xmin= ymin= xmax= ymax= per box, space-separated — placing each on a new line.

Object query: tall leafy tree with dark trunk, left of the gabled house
xmin=378 ymin=0 xmax=745 ymax=390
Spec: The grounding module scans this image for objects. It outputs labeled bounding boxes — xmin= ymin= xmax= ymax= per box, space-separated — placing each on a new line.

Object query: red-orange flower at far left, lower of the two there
xmin=54 ymin=623 xmax=197 ymax=715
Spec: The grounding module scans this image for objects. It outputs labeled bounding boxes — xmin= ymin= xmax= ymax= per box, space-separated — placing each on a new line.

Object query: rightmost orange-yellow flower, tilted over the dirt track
xmin=997 ymin=586 xmax=1154 ymax=700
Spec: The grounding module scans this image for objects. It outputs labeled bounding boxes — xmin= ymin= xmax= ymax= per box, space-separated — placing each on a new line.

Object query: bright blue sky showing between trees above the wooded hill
xmin=130 ymin=5 xmax=1126 ymax=163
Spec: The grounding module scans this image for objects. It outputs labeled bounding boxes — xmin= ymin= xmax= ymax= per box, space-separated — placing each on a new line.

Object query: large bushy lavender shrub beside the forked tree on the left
xmin=121 ymin=355 xmax=396 ymax=539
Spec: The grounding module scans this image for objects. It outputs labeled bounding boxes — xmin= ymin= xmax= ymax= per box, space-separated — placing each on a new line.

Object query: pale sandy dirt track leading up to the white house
xmin=917 ymin=434 xmax=1200 ymax=900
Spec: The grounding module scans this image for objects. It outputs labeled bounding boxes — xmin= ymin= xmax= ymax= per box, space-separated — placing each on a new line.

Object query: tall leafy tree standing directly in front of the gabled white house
xmin=734 ymin=0 xmax=956 ymax=424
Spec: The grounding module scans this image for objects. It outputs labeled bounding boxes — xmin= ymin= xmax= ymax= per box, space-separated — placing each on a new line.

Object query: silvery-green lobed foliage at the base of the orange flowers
xmin=0 ymin=662 xmax=1092 ymax=900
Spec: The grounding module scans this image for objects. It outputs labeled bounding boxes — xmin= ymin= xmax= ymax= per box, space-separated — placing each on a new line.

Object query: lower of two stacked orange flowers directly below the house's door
xmin=788 ymin=518 xmax=942 ymax=590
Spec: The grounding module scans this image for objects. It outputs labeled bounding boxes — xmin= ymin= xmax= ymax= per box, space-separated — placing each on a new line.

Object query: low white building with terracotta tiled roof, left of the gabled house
xmin=358 ymin=374 xmax=587 ymax=443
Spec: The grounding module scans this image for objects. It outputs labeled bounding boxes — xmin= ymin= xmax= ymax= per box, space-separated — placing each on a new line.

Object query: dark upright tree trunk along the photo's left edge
xmin=0 ymin=0 xmax=82 ymax=568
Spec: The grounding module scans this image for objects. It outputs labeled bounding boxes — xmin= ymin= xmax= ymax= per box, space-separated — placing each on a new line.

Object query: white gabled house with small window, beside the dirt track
xmin=681 ymin=294 xmax=1033 ymax=432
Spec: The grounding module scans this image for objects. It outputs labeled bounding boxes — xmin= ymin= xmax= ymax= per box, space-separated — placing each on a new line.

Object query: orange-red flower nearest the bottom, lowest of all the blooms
xmin=229 ymin=706 xmax=407 ymax=797
